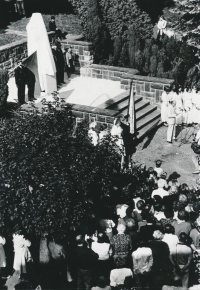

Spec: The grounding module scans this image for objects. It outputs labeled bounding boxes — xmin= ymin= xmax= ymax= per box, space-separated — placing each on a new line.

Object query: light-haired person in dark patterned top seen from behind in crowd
xmin=110 ymin=224 xmax=132 ymax=267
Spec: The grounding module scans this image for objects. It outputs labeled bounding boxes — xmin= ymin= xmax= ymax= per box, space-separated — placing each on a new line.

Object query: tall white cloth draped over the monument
xmin=26 ymin=13 xmax=57 ymax=93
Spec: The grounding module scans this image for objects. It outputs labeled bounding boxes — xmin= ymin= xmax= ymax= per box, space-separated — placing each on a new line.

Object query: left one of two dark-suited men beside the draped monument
xmin=15 ymin=60 xmax=26 ymax=105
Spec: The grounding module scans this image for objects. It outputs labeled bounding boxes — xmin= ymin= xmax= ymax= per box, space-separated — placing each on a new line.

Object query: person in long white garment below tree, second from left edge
xmin=13 ymin=234 xmax=32 ymax=274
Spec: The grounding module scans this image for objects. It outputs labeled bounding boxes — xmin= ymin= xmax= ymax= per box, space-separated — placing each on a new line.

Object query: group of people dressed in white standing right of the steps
xmin=160 ymin=87 xmax=200 ymax=143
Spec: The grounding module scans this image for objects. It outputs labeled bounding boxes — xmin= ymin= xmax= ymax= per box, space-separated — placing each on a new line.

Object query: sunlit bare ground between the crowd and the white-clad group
xmin=133 ymin=126 xmax=197 ymax=185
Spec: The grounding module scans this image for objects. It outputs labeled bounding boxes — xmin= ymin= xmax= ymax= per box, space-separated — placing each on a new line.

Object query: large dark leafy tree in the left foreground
xmin=0 ymin=105 xmax=119 ymax=239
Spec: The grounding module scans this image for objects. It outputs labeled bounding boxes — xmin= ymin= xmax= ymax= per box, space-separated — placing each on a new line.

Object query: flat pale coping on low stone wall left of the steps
xmin=67 ymin=103 xmax=119 ymax=117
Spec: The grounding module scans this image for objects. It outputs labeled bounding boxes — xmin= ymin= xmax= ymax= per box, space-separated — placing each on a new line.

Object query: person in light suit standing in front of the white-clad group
xmin=167 ymin=101 xmax=177 ymax=143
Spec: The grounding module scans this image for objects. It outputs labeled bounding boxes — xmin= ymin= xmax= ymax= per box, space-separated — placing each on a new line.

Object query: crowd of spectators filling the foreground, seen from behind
xmin=0 ymin=160 xmax=200 ymax=290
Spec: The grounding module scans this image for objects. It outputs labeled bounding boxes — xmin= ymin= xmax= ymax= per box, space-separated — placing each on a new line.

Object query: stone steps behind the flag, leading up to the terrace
xmin=98 ymin=91 xmax=160 ymax=139
